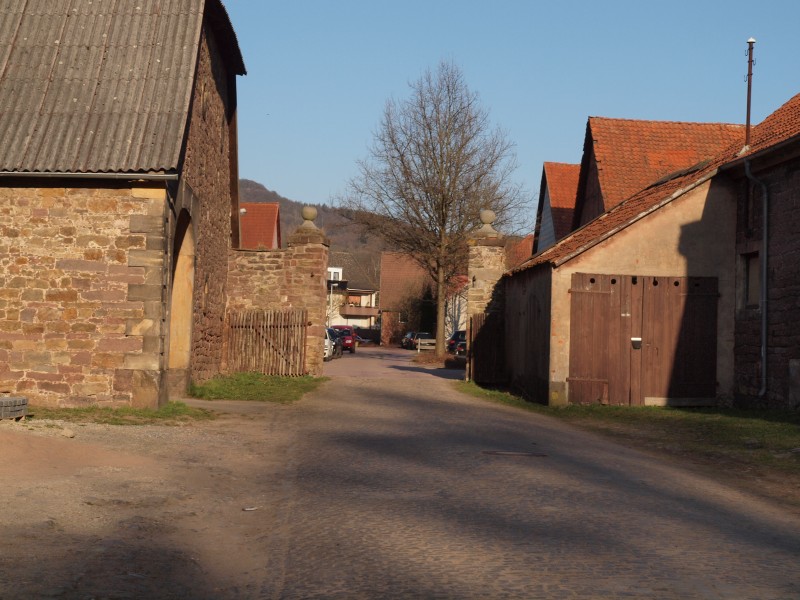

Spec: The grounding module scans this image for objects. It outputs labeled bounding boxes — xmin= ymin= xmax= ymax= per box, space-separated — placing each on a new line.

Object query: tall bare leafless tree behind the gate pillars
xmin=345 ymin=62 xmax=529 ymax=355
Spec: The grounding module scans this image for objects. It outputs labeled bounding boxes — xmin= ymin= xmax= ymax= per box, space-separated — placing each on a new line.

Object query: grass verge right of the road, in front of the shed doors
xmin=457 ymin=381 xmax=800 ymax=476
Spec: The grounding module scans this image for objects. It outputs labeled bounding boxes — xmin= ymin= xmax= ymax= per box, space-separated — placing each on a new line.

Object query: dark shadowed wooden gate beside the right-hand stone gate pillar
xmin=467 ymin=313 xmax=505 ymax=384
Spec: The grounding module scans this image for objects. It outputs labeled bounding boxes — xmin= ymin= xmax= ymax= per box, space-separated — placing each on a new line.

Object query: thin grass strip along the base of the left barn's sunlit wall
xmin=27 ymin=402 xmax=216 ymax=425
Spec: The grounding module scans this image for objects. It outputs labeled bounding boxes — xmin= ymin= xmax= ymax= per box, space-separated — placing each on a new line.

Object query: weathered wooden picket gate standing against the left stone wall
xmin=226 ymin=310 xmax=308 ymax=377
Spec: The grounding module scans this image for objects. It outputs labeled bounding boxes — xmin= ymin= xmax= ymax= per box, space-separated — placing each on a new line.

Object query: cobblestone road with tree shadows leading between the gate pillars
xmin=255 ymin=349 xmax=800 ymax=599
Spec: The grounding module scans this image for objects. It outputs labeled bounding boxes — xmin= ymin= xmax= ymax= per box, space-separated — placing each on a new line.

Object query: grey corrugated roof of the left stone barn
xmin=0 ymin=0 xmax=245 ymax=173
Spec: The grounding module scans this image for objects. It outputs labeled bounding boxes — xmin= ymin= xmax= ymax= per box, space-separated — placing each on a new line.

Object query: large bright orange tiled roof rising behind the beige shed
xmin=582 ymin=117 xmax=744 ymax=210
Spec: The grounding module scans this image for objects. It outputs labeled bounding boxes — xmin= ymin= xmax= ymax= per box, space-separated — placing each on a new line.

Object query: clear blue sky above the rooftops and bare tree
xmin=224 ymin=0 xmax=800 ymax=218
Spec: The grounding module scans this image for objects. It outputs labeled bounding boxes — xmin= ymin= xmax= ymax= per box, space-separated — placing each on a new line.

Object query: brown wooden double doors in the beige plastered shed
xmin=568 ymin=273 xmax=719 ymax=405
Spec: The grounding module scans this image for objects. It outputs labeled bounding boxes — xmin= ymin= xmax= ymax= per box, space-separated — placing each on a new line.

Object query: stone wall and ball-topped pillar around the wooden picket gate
xmin=228 ymin=222 xmax=330 ymax=376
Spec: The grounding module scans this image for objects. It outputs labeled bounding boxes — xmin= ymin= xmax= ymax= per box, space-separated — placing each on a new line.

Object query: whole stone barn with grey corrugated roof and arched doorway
xmin=0 ymin=0 xmax=245 ymax=407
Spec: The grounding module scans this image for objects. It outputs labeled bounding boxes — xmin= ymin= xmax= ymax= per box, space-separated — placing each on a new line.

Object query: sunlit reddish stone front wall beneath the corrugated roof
xmin=0 ymin=180 xmax=166 ymax=406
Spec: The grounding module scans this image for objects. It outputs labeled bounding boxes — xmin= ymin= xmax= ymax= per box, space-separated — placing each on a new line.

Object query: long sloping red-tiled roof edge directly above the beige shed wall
xmin=506 ymin=94 xmax=800 ymax=275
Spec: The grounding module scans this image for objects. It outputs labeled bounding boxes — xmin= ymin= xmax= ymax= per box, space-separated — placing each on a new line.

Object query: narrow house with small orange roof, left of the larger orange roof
xmin=533 ymin=162 xmax=581 ymax=254
